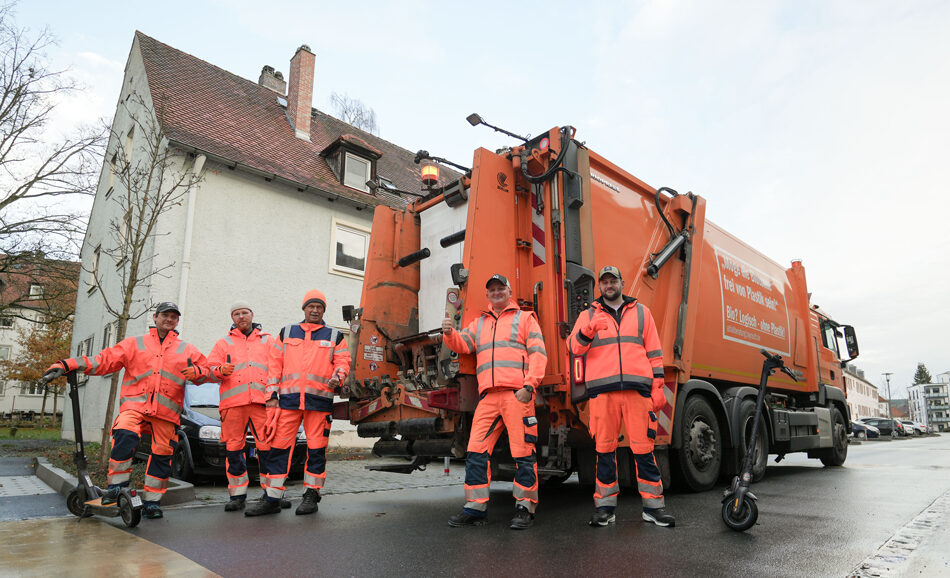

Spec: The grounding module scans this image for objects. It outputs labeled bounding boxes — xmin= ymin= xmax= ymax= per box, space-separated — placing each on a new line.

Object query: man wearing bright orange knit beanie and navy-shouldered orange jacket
xmin=244 ymin=289 xmax=350 ymax=516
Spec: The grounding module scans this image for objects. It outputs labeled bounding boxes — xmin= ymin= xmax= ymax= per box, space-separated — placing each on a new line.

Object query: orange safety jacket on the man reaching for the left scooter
xmin=63 ymin=327 xmax=210 ymax=425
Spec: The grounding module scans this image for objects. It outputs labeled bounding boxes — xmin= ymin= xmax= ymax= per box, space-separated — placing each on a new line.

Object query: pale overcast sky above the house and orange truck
xmin=16 ymin=0 xmax=950 ymax=398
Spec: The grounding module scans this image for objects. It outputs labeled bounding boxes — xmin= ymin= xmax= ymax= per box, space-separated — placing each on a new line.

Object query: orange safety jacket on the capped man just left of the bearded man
xmin=442 ymin=301 xmax=548 ymax=394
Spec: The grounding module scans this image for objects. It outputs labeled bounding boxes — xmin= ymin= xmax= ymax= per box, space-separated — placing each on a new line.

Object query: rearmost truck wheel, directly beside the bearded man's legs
xmin=676 ymin=395 xmax=722 ymax=492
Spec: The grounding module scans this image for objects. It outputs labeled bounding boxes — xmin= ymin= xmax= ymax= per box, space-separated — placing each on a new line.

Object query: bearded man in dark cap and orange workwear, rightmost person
xmin=568 ymin=266 xmax=676 ymax=527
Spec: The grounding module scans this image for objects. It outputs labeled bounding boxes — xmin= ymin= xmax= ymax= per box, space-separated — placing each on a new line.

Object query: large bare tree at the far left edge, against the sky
xmin=0 ymin=4 xmax=105 ymax=314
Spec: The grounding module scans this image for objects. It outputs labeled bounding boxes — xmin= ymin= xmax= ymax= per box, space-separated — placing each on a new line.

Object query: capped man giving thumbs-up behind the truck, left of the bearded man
xmin=442 ymin=275 xmax=548 ymax=530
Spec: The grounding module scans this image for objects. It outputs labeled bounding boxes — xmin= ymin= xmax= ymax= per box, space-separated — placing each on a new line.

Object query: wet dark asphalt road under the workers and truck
xmin=119 ymin=435 xmax=950 ymax=576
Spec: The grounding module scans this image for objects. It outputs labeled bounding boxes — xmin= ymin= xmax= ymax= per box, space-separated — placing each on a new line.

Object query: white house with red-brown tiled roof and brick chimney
xmin=64 ymin=32 xmax=451 ymax=439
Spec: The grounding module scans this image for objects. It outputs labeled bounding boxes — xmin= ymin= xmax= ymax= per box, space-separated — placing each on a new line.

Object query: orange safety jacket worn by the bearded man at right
xmin=567 ymin=295 xmax=665 ymax=401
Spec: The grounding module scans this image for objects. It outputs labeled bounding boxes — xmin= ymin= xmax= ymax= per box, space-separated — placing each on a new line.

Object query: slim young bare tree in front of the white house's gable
xmin=84 ymin=93 xmax=200 ymax=465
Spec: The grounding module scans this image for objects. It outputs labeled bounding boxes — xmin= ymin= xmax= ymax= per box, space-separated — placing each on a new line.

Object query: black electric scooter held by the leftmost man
xmin=40 ymin=370 xmax=142 ymax=528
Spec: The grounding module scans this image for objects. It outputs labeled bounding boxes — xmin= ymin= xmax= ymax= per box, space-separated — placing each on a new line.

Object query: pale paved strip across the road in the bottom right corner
xmin=848 ymin=491 xmax=950 ymax=578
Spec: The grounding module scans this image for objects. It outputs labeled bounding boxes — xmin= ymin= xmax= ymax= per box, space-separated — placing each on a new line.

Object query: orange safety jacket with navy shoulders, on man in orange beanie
xmin=267 ymin=322 xmax=350 ymax=411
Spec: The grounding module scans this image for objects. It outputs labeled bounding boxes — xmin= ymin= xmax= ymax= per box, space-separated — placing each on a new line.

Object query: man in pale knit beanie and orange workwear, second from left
xmin=208 ymin=301 xmax=290 ymax=512
